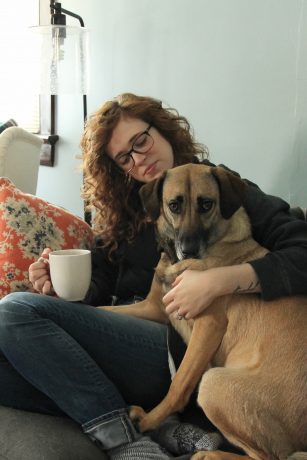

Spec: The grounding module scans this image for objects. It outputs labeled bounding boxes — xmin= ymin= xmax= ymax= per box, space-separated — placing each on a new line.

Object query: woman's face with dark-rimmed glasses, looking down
xmin=107 ymin=117 xmax=174 ymax=182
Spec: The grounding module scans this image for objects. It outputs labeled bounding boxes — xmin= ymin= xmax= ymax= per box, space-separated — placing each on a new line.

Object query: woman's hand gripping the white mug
xmin=29 ymin=248 xmax=54 ymax=295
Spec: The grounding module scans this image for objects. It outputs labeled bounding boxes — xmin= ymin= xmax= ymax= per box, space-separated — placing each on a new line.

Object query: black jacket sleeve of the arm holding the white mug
xmin=83 ymin=248 xmax=118 ymax=306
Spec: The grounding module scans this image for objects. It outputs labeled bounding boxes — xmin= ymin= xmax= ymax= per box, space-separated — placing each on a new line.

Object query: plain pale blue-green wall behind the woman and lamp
xmin=38 ymin=0 xmax=307 ymax=215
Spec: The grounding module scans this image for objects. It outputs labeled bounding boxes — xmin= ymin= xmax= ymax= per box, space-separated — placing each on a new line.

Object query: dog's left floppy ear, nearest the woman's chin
xmin=139 ymin=172 xmax=166 ymax=220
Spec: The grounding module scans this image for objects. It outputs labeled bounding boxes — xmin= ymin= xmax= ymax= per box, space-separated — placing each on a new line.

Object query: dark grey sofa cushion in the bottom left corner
xmin=0 ymin=406 xmax=107 ymax=460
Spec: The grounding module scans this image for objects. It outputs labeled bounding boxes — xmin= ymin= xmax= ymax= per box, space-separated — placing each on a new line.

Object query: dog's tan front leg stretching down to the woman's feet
xmin=130 ymin=307 xmax=227 ymax=431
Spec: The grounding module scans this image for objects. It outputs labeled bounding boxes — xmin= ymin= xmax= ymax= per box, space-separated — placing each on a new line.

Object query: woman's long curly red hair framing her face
xmin=81 ymin=93 xmax=206 ymax=252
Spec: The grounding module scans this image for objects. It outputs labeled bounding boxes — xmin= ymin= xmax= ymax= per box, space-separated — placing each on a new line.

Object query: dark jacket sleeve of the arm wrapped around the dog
xmin=244 ymin=181 xmax=307 ymax=300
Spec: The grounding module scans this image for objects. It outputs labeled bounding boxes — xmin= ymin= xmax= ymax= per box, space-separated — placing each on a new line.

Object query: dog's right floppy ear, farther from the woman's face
xmin=211 ymin=166 xmax=246 ymax=219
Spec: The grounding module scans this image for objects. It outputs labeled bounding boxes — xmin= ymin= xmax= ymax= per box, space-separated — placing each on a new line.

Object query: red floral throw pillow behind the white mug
xmin=0 ymin=178 xmax=94 ymax=298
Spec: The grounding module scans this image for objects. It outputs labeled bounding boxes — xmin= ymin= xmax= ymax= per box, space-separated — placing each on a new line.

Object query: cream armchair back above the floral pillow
xmin=0 ymin=126 xmax=43 ymax=195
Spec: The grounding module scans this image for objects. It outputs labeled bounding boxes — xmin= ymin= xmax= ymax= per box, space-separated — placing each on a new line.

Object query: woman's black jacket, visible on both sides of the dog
xmin=84 ymin=161 xmax=307 ymax=305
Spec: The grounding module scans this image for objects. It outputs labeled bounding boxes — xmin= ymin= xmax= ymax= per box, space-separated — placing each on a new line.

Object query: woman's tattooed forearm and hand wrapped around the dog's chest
xmin=162 ymin=263 xmax=261 ymax=319
